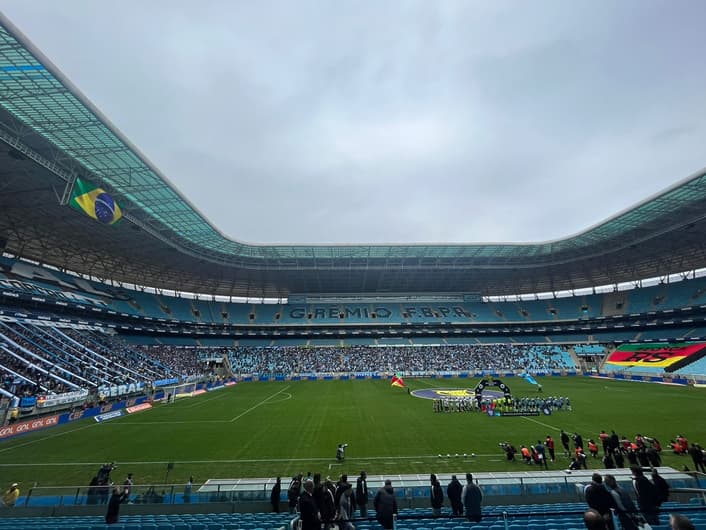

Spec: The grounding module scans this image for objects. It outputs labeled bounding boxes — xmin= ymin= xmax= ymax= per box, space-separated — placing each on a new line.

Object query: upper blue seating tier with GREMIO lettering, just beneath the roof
xmin=0 ymin=257 xmax=706 ymax=331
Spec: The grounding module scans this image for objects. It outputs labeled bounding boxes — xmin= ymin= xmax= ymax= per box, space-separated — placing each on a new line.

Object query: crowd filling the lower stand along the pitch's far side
xmin=230 ymin=345 xmax=575 ymax=374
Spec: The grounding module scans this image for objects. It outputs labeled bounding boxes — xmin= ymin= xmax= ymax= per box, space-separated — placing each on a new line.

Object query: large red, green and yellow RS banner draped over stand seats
xmin=606 ymin=342 xmax=706 ymax=372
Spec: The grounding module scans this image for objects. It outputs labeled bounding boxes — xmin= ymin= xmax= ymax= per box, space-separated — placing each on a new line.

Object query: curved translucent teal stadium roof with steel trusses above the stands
xmin=0 ymin=14 xmax=706 ymax=297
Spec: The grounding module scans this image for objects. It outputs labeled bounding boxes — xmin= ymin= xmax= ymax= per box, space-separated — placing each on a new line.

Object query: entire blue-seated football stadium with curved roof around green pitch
xmin=0 ymin=6 xmax=706 ymax=530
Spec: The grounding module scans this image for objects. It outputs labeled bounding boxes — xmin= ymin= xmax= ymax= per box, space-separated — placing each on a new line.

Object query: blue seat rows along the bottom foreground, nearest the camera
xmin=0 ymin=502 xmax=706 ymax=530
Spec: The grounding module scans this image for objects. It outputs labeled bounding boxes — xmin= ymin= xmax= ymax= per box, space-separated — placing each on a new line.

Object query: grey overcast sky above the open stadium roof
xmin=0 ymin=0 xmax=706 ymax=243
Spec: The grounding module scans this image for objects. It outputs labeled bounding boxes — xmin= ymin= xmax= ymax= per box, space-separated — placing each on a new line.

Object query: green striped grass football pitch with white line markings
xmin=0 ymin=377 xmax=706 ymax=490
